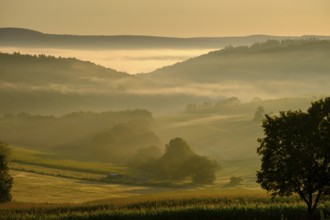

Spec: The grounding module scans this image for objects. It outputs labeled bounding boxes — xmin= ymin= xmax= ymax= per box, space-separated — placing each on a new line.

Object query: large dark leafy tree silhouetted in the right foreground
xmin=257 ymin=97 xmax=330 ymax=219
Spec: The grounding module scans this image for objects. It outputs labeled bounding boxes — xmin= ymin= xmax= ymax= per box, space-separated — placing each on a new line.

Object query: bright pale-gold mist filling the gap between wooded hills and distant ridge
xmin=0 ymin=47 xmax=213 ymax=74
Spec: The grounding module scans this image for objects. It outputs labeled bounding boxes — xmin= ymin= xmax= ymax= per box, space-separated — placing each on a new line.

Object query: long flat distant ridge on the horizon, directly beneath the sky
xmin=0 ymin=27 xmax=330 ymax=49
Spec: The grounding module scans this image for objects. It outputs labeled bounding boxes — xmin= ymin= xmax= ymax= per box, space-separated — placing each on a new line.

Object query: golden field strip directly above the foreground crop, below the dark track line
xmin=11 ymin=168 xmax=263 ymax=203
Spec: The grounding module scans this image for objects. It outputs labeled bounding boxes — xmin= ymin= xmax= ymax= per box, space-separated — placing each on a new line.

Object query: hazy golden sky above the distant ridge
xmin=0 ymin=0 xmax=330 ymax=37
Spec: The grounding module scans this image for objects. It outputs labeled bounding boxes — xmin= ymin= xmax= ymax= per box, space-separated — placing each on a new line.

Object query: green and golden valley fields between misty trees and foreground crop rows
xmin=10 ymin=147 xmax=260 ymax=203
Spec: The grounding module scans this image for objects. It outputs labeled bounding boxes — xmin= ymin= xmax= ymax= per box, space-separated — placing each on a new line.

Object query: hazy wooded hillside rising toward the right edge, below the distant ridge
xmin=152 ymin=40 xmax=330 ymax=82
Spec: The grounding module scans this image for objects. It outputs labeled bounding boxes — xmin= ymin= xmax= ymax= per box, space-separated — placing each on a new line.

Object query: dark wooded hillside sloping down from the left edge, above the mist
xmin=0 ymin=53 xmax=130 ymax=83
